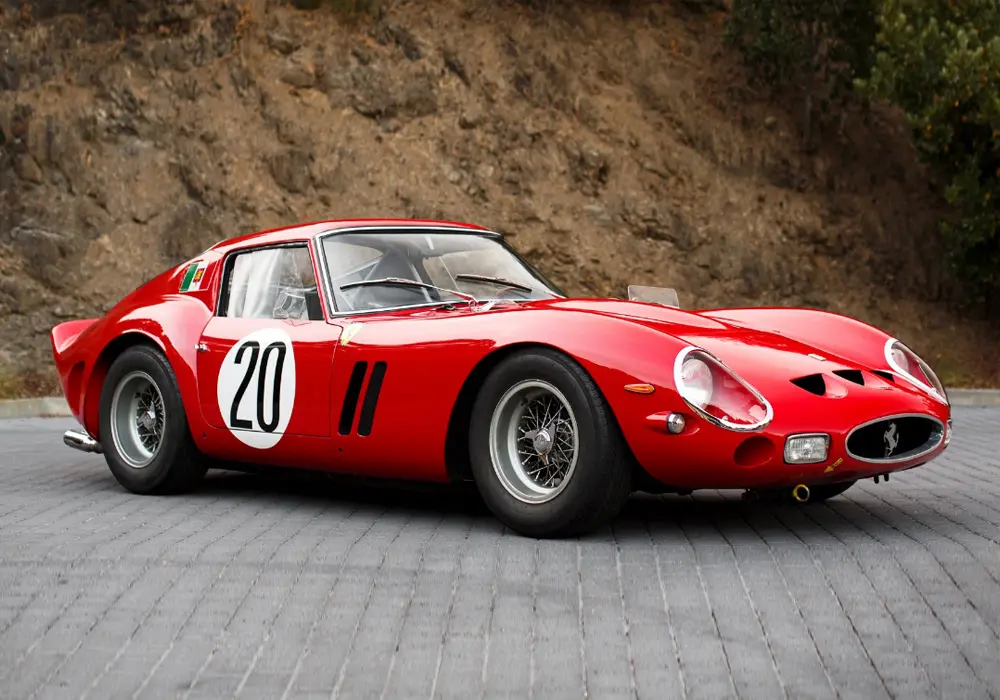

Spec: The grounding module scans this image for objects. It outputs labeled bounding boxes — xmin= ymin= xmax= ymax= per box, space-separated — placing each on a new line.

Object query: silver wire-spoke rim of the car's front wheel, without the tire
xmin=490 ymin=379 xmax=580 ymax=504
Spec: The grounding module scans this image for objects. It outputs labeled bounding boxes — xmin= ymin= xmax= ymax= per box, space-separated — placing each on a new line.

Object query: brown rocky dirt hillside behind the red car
xmin=0 ymin=0 xmax=1000 ymax=393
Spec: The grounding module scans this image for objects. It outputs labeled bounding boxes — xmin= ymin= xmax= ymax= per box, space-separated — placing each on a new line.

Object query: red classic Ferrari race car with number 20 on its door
xmin=51 ymin=220 xmax=951 ymax=536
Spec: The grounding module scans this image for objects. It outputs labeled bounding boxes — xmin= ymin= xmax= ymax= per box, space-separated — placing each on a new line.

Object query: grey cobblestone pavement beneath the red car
xmin=0 ymin=408 xmax=1000 ymax=700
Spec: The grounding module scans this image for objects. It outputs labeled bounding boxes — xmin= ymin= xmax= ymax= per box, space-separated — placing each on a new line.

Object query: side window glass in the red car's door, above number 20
xmin=219 ymin=245 xmax=323 ymax=321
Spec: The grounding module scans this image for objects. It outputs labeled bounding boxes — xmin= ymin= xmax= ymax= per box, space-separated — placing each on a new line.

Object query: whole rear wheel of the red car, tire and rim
xmin=100 ymin=345 xmax=206 ymax=494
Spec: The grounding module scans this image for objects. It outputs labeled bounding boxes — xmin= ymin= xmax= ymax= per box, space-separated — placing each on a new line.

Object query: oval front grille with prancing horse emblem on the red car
xmin=847 ymin=415 xmax=944 ymax=462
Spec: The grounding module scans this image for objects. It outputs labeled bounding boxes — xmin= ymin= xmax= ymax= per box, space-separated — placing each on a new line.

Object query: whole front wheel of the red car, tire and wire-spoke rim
xmin=469 ymin=350 xmax=631 ymax=537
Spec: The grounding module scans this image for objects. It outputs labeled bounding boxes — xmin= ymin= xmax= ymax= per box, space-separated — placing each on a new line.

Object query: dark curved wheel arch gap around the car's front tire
xmin=445 ymin=341 xmax=644 ymax=481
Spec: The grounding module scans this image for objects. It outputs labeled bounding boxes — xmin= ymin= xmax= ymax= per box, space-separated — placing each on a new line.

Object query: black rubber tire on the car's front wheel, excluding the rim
xmin=469 ymin=349 xmax=632 ymax=537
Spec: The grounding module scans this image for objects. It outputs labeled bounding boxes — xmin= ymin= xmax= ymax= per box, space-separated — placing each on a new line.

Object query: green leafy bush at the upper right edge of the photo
xmin=859 ymin=0 xmax=1000 ymax=301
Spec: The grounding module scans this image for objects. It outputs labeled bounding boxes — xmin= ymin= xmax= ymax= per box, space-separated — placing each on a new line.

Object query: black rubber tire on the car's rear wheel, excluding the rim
xmin=100 ymin=345 xmax=206 ymax=494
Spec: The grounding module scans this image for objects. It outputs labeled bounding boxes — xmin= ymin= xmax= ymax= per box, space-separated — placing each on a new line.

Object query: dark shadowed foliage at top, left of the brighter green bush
xmin=726 ymin=0 xmax=877 ymax=142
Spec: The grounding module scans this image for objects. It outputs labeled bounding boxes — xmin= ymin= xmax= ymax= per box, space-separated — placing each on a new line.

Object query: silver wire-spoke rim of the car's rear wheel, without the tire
xmin=111 ymin=371 xmax=167 ymax=469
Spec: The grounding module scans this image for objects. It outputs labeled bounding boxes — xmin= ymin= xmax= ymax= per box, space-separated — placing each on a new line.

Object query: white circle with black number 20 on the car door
xmin=218 ymin=328 xmax=295 ymax=450
